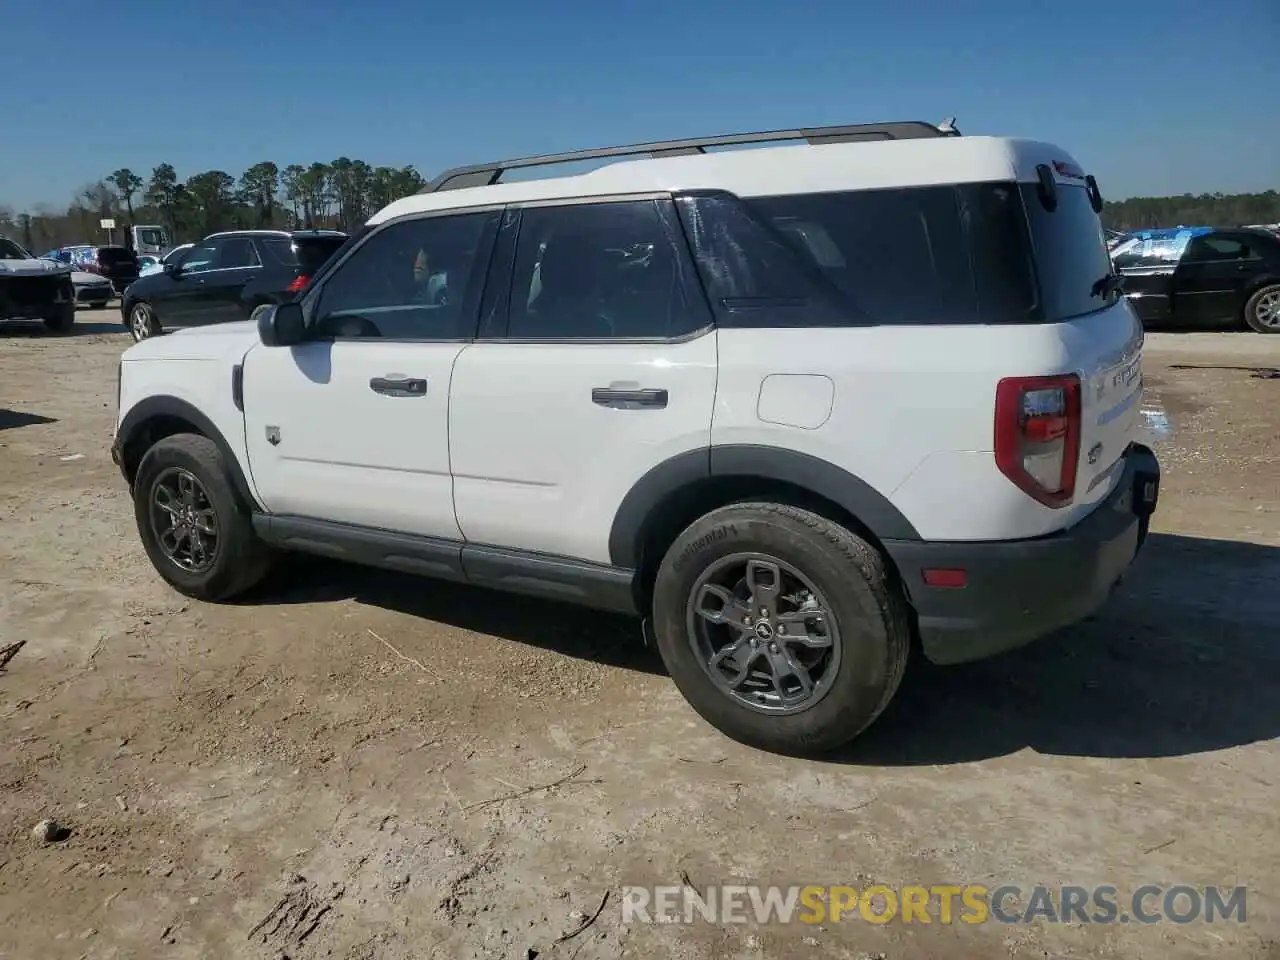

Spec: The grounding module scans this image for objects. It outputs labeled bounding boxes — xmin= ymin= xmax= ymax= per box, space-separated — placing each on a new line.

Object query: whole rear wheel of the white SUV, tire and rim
xmin=653 ymin=503 xmax=910 ymax=755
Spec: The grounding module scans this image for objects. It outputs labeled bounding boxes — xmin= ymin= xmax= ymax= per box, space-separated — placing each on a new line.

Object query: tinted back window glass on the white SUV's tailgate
xmin=1020 ymin=183 xmax=1111 ymax=320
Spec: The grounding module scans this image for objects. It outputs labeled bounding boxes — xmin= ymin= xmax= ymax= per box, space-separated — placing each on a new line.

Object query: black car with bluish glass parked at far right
xmin=1111 ymin=227 xmax=1280 ymax=333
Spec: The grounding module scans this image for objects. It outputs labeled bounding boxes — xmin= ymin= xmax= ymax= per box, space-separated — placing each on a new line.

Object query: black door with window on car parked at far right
xmin=1174 ymin=233 xmax=1267 ymax=326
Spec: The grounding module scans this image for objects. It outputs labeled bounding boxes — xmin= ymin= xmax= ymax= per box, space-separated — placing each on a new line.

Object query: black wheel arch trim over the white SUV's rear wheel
xmin=609 ymin=444 xmax=920 ymax=570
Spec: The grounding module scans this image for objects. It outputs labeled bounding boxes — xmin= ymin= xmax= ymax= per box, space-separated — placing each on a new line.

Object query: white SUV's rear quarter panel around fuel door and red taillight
xmin=712 ymin=307 xmax=1140 ymax=540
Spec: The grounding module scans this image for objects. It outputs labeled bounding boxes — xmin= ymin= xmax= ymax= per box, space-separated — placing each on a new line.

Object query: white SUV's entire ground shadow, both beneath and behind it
xmin=238 ymin=534 xmax=1280 ymax=765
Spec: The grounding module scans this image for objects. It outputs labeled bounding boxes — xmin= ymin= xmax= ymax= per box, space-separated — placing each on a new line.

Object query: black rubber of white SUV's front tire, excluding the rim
xmin=133 ymin=434 xmax=253 ymax=598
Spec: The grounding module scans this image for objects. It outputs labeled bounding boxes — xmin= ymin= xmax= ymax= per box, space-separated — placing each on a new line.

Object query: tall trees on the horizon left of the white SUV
xmin=0 ymin=156 xmax=425 ymax=253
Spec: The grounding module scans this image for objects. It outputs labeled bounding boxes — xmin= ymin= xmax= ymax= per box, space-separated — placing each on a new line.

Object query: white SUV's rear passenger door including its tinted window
xmin=449 ymin=198 xmax=716 ymax=575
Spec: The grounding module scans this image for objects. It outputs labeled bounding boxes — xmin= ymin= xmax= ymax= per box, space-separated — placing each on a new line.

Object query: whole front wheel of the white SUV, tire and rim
xmin=133 ymin=434 xmax=270 ymax=600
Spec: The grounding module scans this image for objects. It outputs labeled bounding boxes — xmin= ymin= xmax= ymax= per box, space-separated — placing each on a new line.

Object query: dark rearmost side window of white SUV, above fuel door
xmin=681 ymin=183 xmax=1041 ymax=326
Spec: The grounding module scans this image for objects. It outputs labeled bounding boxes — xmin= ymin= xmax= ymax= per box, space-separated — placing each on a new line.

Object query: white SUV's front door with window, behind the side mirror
xmin=243 ymin=211 xmax=500 ymax=544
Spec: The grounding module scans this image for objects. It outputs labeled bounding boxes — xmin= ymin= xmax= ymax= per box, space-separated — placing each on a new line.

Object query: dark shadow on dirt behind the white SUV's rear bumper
xmin=835 ymin=534 xmax=1280 ymax=765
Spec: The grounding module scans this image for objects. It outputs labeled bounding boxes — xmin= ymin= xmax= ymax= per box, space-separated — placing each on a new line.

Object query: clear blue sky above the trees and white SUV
xmin=0 ymin=0 xmax=1280 ymax=210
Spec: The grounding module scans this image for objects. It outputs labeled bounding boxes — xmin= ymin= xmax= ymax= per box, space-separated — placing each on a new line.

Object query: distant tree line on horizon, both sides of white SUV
xmin=0 ymin=156 xmax=1280 ymax=253
